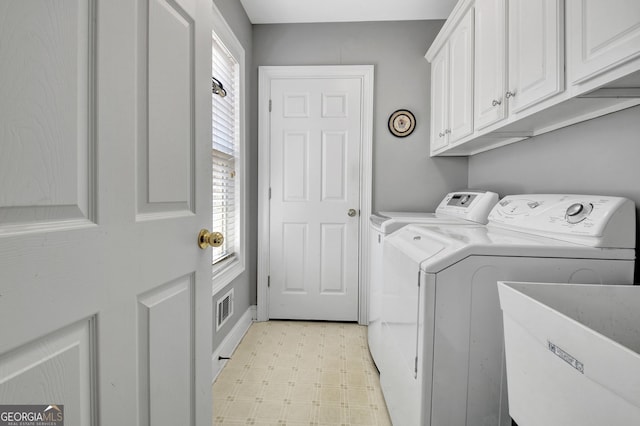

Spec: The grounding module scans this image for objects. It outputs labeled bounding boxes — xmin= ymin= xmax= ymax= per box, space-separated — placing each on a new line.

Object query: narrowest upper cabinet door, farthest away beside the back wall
xmin=431 ymin=45 xmax=449 ymax=152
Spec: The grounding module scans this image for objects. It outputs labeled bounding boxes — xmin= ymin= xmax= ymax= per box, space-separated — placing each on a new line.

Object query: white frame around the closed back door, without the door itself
xmin=257 ymin=65 xmax=373 ymax=325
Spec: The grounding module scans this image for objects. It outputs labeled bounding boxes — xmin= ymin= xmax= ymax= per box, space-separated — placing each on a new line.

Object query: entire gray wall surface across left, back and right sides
xmin=213 ymin=11 xmax=640 ymax=349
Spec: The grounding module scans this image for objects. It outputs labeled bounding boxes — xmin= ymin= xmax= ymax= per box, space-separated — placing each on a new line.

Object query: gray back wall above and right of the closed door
xmin=252 ymin=21 xmax=467 ymax=220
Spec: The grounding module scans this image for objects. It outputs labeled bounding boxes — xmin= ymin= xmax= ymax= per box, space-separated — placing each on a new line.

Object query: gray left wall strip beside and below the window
xmin=212 ymin=0 xmax=258 ymax=350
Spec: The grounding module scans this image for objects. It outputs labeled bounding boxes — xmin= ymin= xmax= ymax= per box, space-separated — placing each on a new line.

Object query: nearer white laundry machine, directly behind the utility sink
xmin=378 ymin=194 xmax=636 ymax=426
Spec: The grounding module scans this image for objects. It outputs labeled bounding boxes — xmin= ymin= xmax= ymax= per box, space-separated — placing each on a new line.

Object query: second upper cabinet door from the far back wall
xmin=448 ymin=9 xmax=473 ymax=144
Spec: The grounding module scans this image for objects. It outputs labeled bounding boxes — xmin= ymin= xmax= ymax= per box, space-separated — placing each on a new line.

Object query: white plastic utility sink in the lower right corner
xmin=498 ymin=282 xmax=640 ymax=426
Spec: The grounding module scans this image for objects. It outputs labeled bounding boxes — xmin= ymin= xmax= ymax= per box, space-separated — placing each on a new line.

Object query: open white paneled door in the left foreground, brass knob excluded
xmin=0 ymin=0 xmax=212 ymax=426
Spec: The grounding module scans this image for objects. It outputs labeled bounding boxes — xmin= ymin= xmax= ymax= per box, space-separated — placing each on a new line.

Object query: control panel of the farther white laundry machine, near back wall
xmin=436 ymin=190 xmax=499 ymax=224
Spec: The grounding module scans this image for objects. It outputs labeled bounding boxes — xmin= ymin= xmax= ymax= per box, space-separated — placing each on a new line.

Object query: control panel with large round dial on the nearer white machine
xmin=489 ymin=194 xmax=635 ymax=248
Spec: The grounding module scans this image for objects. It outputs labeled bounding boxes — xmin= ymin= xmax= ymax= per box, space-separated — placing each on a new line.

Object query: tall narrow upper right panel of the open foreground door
xmin=148 ymin=0 xmax=193 ymax=203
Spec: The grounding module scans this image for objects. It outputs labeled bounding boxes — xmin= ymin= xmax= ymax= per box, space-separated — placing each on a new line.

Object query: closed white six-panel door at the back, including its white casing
xmin=258 ymin=66 xmax=373 ymax=323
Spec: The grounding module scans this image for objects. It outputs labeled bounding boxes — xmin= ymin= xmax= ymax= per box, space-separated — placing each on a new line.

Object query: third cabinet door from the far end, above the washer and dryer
xmin=474 ymin=0 xmax=506 ymax=129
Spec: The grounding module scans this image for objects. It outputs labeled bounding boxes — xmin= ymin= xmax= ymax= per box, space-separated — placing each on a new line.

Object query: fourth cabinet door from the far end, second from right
xmin=505 ymin=0 xmax=564 ymax=114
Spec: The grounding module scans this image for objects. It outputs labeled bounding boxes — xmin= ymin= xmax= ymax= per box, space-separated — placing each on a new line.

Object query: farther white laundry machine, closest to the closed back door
xmin=368 ymin=190 xmax=499 ymax=364
